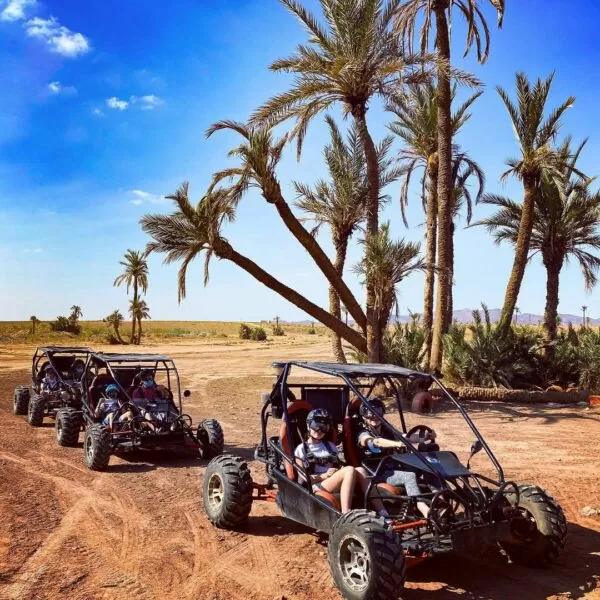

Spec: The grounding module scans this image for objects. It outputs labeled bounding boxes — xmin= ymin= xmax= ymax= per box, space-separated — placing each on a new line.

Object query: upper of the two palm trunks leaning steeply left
xmin=263 ymin=179 xmax=367 ymax=331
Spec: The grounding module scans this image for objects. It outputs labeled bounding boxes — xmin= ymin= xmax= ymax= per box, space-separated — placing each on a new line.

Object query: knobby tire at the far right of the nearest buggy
xmin=501 ymin=485 xmax=567 ymax=567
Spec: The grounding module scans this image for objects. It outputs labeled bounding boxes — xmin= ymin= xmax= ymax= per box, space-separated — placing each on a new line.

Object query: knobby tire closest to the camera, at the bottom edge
xmin=328 ymin=509 xmax=406 ymax=600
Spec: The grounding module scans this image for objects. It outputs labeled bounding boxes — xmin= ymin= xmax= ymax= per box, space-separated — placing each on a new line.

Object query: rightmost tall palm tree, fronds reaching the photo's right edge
xmin=476 ymin=140 xmax=600 ymax=341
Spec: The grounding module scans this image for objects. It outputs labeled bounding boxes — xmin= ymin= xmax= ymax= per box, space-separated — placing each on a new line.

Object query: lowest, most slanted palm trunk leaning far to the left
xmin=214 ymin=240 xmax=367 ymax=353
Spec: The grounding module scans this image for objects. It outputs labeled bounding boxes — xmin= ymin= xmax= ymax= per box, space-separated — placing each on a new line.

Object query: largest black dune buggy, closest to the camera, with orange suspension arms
xmin=203 ymin=362 xmax=567 ymax=600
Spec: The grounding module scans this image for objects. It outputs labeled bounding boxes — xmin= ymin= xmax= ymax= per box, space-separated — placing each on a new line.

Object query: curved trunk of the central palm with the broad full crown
xmin=352 ymin=104 xmax=381 ymax=363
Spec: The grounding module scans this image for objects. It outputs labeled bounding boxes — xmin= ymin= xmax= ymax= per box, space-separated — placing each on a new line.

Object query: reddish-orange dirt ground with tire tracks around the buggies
xmin=0 ymin=341 xmax=600 ymax=600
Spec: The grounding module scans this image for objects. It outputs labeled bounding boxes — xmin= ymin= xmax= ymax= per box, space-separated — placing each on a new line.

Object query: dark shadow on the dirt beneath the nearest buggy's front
xmin=403 ymin=523 xmax=600 ymax=600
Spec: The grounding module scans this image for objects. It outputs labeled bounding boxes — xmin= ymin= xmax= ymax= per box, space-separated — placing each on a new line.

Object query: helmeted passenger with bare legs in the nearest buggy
xmin=294 ymin=408 xmax=356 ymax=513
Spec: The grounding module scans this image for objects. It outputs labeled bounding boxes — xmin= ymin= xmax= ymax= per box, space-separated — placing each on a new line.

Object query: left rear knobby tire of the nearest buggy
xmin=203 ymin=454 xmax=252 ymax=529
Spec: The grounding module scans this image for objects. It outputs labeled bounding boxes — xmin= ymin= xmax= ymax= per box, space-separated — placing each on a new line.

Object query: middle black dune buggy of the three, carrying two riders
xmin=77 ymin=353 xmax=224 ymax=471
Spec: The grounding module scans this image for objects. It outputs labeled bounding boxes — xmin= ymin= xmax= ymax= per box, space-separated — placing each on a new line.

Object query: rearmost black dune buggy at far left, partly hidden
xmin=13 ymin=346 xmax=93 ymax=427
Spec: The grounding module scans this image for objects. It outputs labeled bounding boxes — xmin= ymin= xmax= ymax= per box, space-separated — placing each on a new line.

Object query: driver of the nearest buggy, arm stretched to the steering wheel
xmin=358 ymin=398 xmax=436 ymax=517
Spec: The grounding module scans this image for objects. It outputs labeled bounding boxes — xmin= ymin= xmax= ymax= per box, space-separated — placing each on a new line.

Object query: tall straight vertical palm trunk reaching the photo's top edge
xmin=429 ymin=3 xmax=452 ymax=369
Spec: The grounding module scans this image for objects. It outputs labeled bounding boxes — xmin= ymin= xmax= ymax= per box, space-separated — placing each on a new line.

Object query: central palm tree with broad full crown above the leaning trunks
xmin=253 ymin=0 xmax=428 ymax=362
